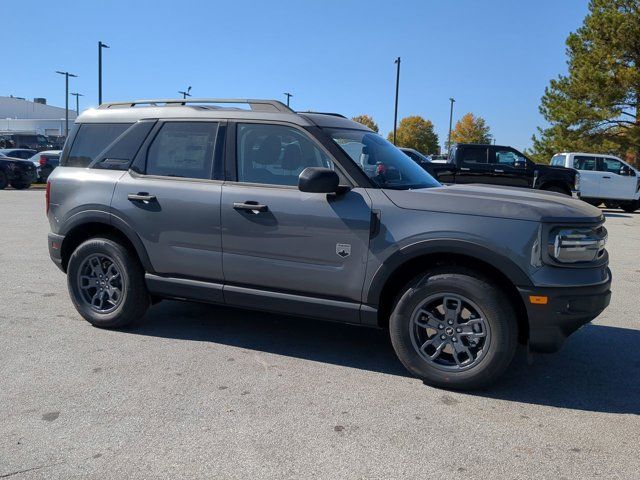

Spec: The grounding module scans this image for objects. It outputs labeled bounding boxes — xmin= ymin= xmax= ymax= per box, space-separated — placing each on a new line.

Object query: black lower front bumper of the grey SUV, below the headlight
xmin=518 ymin=271 xmax=611 ymax=353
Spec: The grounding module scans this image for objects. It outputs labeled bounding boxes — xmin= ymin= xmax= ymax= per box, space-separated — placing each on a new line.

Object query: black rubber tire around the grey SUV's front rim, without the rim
xmin=389 ymin=274 xmax=517 ymax=389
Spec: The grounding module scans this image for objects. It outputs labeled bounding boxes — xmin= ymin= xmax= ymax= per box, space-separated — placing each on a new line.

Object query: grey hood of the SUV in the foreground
xmin=384 ymin=185 xmax=604 ymax=223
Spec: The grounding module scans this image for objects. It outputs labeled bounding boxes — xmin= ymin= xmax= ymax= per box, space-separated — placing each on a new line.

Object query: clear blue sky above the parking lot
xmin=0 ymin=0 xmax=587 ymax=148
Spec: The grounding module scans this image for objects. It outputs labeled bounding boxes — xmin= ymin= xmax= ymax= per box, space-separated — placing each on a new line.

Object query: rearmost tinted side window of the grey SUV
xmin=63 ymin=123 xmax=131 ymax=167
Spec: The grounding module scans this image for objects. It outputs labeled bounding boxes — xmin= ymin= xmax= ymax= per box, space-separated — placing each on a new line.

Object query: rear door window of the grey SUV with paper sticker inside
xmin=146 ymin=122 xmax=218 ymax=179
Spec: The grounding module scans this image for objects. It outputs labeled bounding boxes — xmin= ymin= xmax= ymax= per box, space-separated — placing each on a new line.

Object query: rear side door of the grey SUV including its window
xmin=107 ymin=120 xmax=224 ymax=294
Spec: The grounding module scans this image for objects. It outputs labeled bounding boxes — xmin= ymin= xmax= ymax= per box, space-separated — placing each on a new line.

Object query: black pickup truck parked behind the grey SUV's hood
xmin=420 ymin=143 xmax=579 ymax=195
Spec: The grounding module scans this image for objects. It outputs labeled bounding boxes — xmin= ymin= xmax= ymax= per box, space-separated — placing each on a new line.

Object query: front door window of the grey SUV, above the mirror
xmin=236 ymin=123 xmax=333 ymax=186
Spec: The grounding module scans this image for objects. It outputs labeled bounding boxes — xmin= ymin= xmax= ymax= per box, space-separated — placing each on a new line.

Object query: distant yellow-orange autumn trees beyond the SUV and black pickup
xmin=352 ymin=113 xmax=492 ymax=155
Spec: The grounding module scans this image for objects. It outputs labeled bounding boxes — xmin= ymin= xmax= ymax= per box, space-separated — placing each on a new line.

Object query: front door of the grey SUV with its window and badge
xmin=222 ymin=123 xmax=371 ymax=321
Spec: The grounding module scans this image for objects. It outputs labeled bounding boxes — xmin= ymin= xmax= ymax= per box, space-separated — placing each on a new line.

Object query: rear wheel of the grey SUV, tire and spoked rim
xmin=67 ymin=238 xmax=150 ymax=328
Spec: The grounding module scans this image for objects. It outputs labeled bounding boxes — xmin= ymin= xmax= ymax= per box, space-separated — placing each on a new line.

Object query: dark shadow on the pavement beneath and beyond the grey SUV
xmin=130 ymin=301 xmax=640 ymax=415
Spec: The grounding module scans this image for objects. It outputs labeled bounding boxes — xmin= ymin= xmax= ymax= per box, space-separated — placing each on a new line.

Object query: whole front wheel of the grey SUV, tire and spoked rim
xmin=389 ymin=267 xmax=518 ymax=390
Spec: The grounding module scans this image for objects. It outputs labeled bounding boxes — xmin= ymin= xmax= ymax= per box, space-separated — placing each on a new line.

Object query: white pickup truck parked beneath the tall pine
xmin=551 ymin=152 xmax=640 ymax=212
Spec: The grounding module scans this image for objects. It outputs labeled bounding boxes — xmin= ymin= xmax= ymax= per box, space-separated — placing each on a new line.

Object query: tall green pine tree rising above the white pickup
xmin=532 ymin=0 xmax=640 ymax=166
